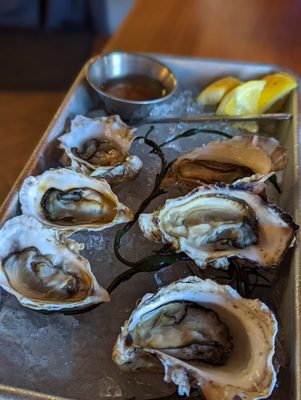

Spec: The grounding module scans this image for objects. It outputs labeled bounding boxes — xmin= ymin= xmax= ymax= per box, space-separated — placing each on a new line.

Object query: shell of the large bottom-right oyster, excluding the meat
xmin=113 ymin=277 xmax=278 ymax=400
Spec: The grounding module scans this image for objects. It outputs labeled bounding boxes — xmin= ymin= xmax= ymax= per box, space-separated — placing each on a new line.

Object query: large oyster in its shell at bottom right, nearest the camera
xmin=113 ymin=277 xmax=278 ymax=400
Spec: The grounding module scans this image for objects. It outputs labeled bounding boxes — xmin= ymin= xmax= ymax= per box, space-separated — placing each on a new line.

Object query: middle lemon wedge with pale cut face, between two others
xmin=216 ymin=80 xmax=266 ymax=116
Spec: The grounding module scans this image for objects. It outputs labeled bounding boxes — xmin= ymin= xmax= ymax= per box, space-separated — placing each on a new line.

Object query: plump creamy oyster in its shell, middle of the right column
xmin=139 ymin=183 xmax=298 ymax=268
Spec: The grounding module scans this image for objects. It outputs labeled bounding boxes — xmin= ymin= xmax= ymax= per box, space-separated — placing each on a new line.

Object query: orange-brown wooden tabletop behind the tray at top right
xmin=105 ymin=0 xmax=301 ymax=75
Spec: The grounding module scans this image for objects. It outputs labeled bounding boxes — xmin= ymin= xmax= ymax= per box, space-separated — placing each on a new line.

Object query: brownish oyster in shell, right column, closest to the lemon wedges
xmin=162 ymin=136 xmax=287 ymax=187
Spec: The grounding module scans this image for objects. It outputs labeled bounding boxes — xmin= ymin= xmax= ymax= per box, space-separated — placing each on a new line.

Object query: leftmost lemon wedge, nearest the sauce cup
xmin=196 ymin=76 xmax=241 ymax=106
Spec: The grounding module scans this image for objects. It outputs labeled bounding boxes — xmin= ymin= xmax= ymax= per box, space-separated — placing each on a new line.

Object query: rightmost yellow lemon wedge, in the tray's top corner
xmin=258 ymin=72 xmax=298 ymax=113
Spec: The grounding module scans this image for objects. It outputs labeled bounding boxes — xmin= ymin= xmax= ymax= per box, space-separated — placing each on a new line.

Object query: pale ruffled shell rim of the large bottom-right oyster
xmin=112 ymin=276 xmax=278 ymax=400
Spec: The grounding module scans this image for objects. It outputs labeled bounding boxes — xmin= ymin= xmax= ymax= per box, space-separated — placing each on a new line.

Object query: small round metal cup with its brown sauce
xmin=86 ymin=52 xmax=177 ymax=120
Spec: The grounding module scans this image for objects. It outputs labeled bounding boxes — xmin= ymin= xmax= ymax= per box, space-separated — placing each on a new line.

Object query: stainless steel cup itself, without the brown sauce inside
xmin=86 ymin=52 xmax=177 ymax=119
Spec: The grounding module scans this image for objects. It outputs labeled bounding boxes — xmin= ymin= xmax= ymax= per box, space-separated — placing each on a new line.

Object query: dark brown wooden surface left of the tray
xmin=0 ymin=37 xmax=107 ymax=205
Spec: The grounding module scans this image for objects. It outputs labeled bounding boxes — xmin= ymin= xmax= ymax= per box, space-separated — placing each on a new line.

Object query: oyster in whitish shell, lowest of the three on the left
xmin=0 ymin=215 xmax=110 ymax=311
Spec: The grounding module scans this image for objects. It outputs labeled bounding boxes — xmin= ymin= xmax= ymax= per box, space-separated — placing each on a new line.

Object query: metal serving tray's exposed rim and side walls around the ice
xmin=0 ymin=55 xmax=301 ymax=400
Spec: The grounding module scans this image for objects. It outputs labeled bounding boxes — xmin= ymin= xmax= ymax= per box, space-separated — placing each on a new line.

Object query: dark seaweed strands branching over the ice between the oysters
xmin=107 ymin=126 xmax=272 ymax=298
